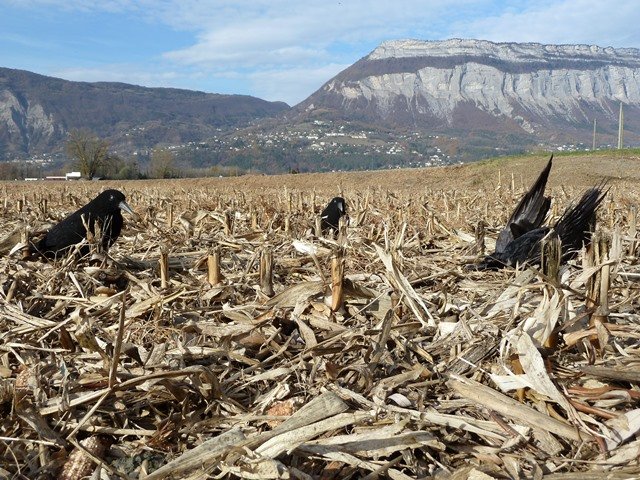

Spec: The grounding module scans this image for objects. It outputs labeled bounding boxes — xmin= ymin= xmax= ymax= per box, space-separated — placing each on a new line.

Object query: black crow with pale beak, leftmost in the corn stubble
xmin=35 ymin=190 xmax=133 ymax=257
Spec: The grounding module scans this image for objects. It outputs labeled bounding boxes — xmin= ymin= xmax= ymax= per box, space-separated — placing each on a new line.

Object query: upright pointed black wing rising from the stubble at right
xmin=495 ymin=154 xmax=553 ymax=253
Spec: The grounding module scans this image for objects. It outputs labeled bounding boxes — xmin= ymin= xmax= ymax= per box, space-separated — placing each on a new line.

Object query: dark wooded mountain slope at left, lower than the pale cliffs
xmin=0 ymin=68 xmax=289 ymax=160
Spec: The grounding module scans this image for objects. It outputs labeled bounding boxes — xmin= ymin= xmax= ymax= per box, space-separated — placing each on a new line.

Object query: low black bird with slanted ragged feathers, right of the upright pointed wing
xmin=478 ymin=185 xmax=607 ymax=270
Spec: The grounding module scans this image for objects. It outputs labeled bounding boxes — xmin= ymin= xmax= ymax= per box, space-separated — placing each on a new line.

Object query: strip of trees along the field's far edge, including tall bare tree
xmin=0 ymin=130 xmax=410 ymax=180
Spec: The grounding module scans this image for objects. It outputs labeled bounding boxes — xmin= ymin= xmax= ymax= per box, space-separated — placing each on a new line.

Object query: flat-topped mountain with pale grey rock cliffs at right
xmin=295 ymin=39 xmax=640 ymax=150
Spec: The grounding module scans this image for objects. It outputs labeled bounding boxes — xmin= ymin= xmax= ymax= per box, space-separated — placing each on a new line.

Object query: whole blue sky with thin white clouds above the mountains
xmin=0 ymin=0 xmax=640 ymax=105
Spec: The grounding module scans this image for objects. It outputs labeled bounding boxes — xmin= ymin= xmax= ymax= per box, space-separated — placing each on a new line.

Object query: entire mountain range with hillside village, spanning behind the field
xmin=0 ymin=39 xmax=640 ymax=172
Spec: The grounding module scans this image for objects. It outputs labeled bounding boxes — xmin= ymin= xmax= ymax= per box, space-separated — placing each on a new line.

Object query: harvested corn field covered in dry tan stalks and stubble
xmin=0 ymin=156 xmax=640 ymax=479
